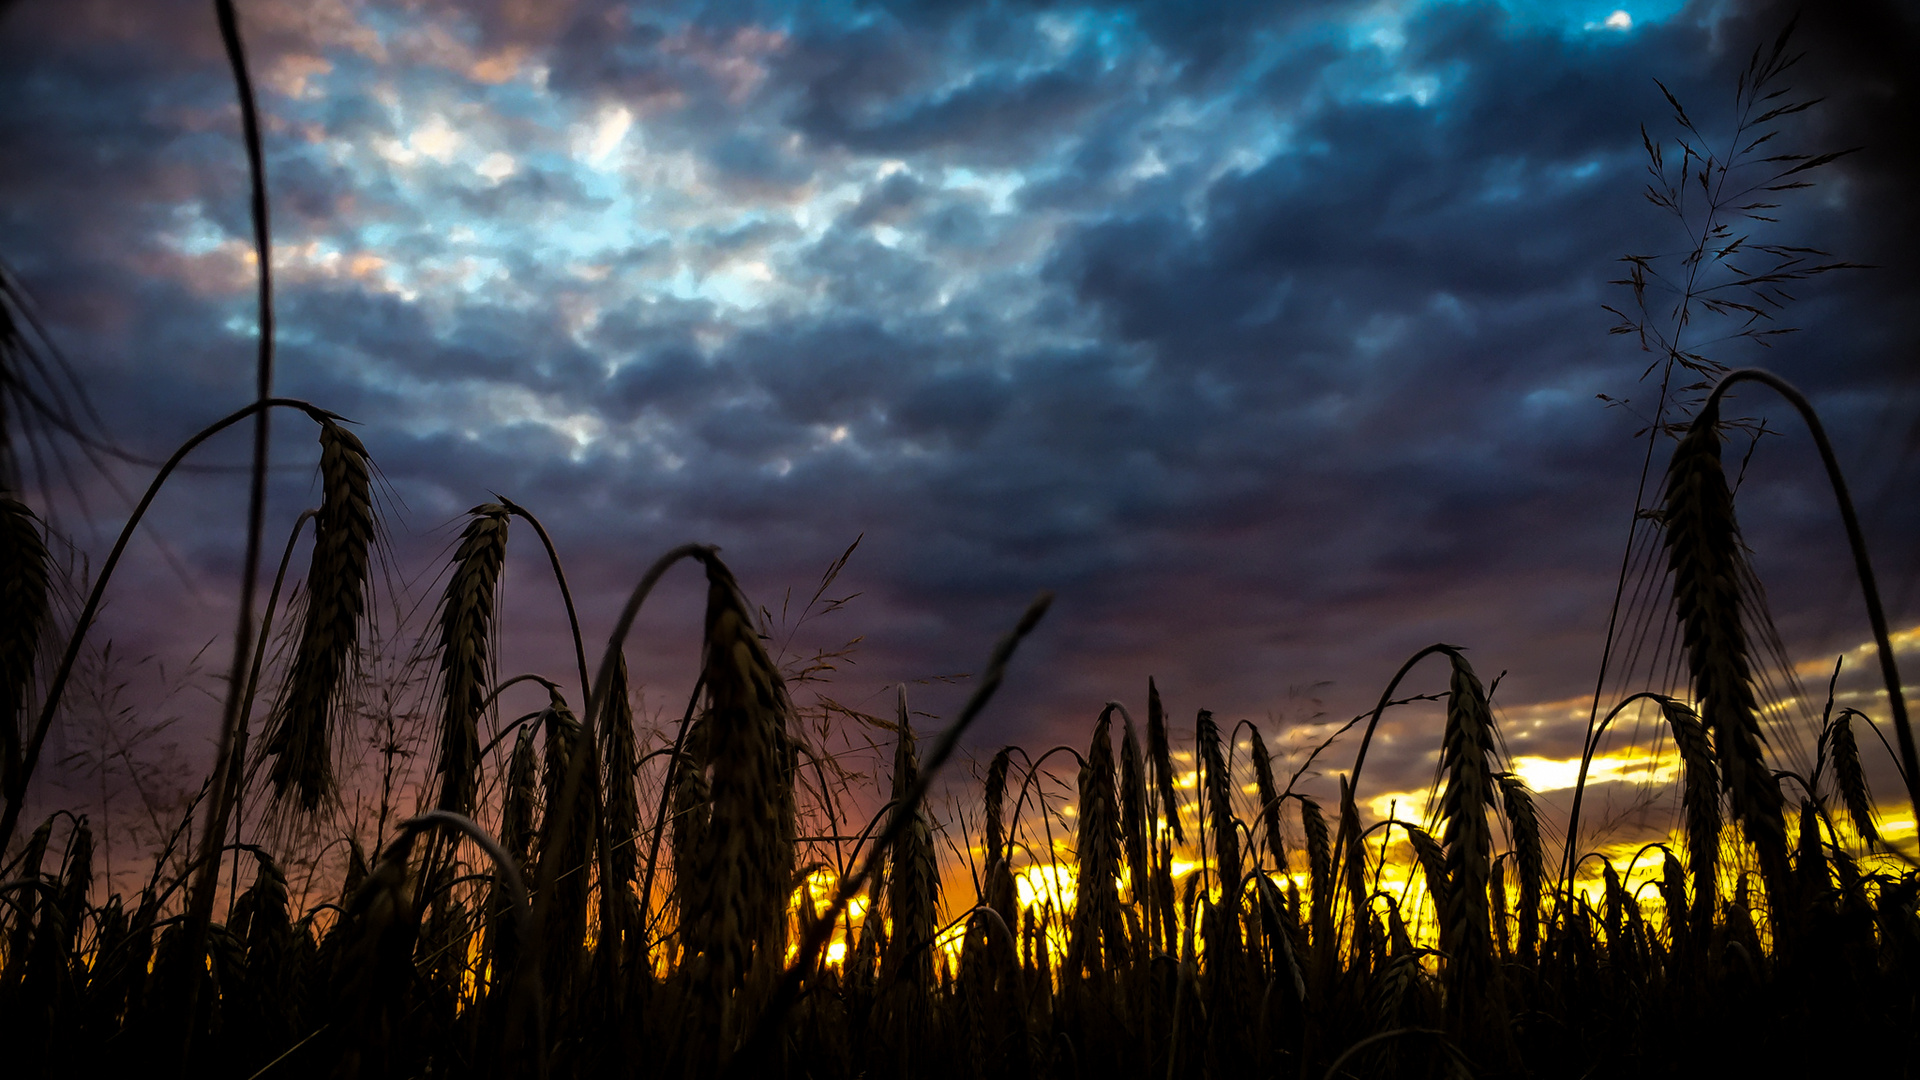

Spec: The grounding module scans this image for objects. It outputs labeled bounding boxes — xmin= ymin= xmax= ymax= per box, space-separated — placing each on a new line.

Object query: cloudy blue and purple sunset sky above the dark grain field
xmin=0 ymin=0 xmax=1920 ymax=876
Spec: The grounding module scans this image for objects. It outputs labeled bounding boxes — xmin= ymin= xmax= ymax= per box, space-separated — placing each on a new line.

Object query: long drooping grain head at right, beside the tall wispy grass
xmin=1665 ymin=404 xmax=1791 ymax=899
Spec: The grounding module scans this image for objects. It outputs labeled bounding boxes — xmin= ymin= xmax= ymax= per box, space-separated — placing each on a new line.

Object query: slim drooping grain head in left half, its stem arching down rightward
xmin=434 ymin=503 xmax=509 ymax=813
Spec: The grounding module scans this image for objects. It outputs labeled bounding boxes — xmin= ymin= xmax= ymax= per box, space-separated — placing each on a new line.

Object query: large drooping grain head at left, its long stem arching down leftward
xmin=267 ymin=421 xmax=374 ymax=813
